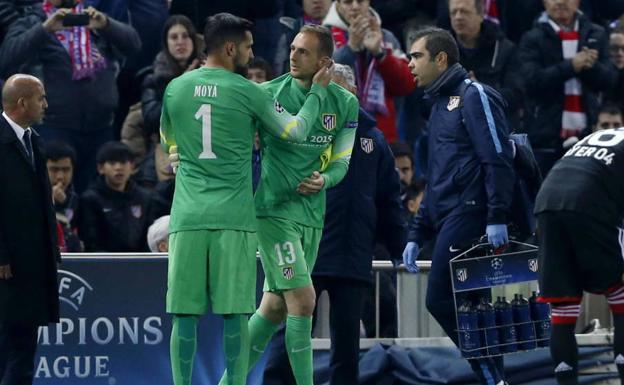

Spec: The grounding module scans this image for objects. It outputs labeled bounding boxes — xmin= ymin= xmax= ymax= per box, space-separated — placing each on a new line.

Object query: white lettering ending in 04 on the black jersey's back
xmin=564 ymin=127 xmax=624 ymax=166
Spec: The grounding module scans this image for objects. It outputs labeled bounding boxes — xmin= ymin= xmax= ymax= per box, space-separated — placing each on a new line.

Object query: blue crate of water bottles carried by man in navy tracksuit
xmin=449 ymin=240 xmax=550 ymax=358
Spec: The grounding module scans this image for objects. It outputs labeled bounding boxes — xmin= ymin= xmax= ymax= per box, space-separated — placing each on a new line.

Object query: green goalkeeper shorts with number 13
xmin=258 ymin=217 xmax=322 ymax=292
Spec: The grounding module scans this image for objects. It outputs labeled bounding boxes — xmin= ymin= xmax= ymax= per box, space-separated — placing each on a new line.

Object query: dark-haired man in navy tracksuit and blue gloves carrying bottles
xmin=403 ymin=28 xmax=515 ymax=385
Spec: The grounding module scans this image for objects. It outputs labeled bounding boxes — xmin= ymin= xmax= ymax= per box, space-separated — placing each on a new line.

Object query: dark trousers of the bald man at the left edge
xmin=0 ymin=323 xmax=38 ymax=385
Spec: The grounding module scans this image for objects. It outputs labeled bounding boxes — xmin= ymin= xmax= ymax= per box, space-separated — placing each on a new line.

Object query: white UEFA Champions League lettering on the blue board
xmin=34 ymin=270 xmax=165 ymax=385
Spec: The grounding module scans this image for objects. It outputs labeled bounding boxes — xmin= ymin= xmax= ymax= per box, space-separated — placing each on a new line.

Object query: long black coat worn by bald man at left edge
xmin=0 ymin=115 xmax=60 ymax=325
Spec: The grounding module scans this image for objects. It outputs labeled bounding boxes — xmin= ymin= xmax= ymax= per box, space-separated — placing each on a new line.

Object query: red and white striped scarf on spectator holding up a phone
xmin=43 ymin=0 xmax=106 ymax=80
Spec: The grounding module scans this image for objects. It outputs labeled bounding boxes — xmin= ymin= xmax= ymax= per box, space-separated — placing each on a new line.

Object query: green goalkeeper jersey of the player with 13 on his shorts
xmin=256 ymin=74 xmax=359 ymax=228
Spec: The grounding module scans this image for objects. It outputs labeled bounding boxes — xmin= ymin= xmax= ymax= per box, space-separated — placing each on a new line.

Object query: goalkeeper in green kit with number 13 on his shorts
xmin=218 ymin=25 xmax=358 ymax=385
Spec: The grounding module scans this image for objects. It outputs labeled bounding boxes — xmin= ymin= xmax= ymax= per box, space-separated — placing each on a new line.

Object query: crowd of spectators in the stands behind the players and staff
xmin=0 ymin=0 xmax=624 ymax=255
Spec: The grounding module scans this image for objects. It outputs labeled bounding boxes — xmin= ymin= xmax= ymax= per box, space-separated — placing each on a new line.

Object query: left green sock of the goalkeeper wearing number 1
xmin=169 ymin=315 xmax=199 ymax=385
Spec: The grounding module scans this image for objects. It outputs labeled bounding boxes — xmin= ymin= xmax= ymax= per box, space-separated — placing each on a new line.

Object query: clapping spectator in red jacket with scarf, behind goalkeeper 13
xmin=323 ymin=0 xmax=416 ymax=143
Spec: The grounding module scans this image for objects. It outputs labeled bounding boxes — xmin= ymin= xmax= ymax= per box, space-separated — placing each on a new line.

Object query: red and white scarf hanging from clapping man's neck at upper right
xmin=548 ymin=19 xmax=587 ymax=139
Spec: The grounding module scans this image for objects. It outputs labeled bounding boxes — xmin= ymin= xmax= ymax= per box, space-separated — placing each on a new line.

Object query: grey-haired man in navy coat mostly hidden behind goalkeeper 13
xmin=263 ymin=64 xmax=407 ymax=385
